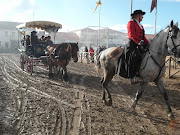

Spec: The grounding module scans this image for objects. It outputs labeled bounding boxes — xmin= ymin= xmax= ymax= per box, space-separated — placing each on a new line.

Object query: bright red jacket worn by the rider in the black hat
xmin=127 ymin=20 xmax=149 ymax=45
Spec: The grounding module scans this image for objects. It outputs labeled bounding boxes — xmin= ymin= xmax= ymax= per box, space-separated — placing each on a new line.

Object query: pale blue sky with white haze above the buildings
xmin=0 ymin=0 xmax=180 ymax=34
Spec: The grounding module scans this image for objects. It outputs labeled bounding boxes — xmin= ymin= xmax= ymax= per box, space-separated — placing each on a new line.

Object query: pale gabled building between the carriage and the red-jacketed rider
xmin=72 ymin=27 xmax=127 ymax=50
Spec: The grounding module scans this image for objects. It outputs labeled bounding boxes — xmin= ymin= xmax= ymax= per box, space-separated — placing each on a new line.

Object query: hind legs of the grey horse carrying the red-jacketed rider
xmin=102 ymin=70 xmax=115 ymax=105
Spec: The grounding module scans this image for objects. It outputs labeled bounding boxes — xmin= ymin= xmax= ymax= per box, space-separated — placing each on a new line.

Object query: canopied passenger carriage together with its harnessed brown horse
xmin=16 ymin=21 xmax=78 ymax=80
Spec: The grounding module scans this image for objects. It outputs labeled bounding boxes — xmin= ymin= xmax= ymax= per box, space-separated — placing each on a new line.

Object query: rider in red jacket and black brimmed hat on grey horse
xmin=127 ymin=10 xmax=149 ymax=83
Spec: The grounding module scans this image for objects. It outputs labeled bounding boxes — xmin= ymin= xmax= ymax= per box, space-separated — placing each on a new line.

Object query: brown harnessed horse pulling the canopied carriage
xmin=47 ymin=43 xmax=79 ymax=81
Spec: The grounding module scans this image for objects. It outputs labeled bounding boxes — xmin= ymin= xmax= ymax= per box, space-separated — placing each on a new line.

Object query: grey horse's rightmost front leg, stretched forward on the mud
xmin=155 ymin=78 xmax=174 ymax=120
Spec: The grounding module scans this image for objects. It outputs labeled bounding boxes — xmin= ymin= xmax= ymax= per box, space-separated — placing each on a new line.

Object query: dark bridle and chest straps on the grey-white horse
xmin=142 ymin=26 xmax=180 ymax=81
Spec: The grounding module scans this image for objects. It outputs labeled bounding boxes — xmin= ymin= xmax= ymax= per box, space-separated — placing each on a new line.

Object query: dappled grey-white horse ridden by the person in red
xmin=96 ymin=20 xmax=180 ymax=120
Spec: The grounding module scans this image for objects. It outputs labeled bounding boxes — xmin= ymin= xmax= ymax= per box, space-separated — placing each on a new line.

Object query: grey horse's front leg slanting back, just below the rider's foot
xmin=131 ymin=81 xmax=147 ymax=111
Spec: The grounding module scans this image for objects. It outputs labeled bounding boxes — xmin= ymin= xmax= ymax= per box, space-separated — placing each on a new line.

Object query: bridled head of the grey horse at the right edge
xmin=166 ymin=20 xmax=180 ymax=57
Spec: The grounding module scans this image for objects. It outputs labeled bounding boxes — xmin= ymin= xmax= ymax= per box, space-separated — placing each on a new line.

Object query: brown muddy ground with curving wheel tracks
xmin=0 ymin=54 xmax=180 ymax=135
